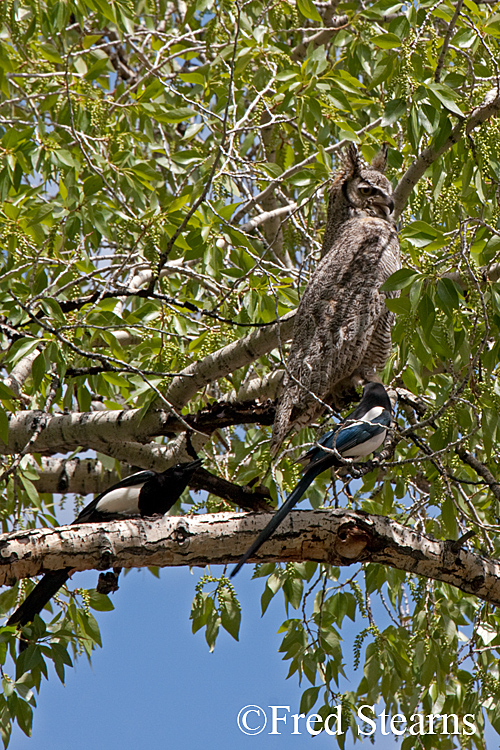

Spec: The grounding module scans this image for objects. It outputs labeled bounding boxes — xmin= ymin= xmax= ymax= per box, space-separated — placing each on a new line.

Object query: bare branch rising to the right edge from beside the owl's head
xmin=392 ymin=88 xmax=500 ymax=219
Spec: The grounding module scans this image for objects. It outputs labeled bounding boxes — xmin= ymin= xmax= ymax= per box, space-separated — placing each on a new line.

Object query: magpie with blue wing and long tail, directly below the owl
xmin=231 ymin=383 xmax=391 ymax=576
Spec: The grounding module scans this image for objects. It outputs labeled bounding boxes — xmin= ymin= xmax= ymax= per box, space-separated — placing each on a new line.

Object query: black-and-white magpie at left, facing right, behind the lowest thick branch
xmin=7 ymin=459 xmax=201 ymax=636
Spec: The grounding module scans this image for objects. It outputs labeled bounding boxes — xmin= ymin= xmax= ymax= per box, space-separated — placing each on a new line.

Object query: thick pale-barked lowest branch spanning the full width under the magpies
xmin=0 ymin=510 xmax=500 ymax=606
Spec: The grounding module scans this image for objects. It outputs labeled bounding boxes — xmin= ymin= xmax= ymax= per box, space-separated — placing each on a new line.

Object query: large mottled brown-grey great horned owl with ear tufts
xmin=271 ymin=144 xmax=401 ymax=455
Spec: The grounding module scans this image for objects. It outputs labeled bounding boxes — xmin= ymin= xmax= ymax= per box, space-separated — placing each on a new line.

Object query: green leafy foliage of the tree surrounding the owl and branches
xmin=0 ymin=0 xmax=500 ymax=747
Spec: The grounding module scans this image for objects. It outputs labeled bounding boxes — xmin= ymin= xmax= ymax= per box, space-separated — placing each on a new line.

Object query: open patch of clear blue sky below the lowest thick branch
xmin=10 ymin=565 xmax=410 ymax=750
